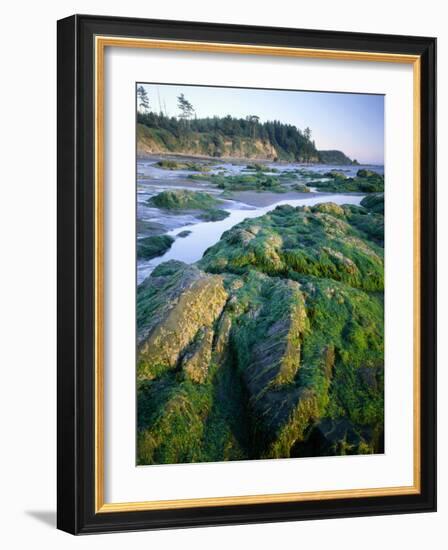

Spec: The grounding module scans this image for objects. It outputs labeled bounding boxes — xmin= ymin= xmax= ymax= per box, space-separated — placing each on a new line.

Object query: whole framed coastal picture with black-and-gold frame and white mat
xmin=58 ymin=15 xmax=436 ymax=534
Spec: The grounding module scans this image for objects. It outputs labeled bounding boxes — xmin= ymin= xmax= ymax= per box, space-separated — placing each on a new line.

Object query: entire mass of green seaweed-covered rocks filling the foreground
xmin=137 ymin=200 xmax=384 ymax=464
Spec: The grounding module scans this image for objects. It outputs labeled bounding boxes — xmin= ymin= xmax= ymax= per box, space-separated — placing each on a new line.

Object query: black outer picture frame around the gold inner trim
xmin=57 ymin=15 xmax=436 ymax=534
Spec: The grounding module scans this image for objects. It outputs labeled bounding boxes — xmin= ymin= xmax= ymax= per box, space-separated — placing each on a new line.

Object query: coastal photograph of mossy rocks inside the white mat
xmin=135 ymin=82 xmax=387 ymax=466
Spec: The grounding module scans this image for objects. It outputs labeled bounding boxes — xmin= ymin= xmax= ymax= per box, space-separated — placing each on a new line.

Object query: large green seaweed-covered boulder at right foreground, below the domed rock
xmin=226 ymin=271 xmax=383 ymax=458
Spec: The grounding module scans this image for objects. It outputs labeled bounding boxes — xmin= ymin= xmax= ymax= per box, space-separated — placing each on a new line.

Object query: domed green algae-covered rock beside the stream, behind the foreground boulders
xmin=199 ymin=203 xmax=384 ymax=291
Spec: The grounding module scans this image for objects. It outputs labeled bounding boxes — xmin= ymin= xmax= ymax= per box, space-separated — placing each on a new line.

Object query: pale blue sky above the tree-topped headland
xmin=138 ymin=83 xmax=384 ymax=164
